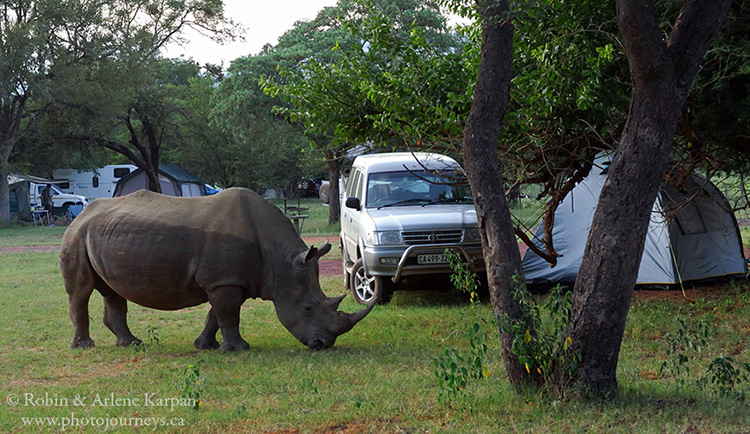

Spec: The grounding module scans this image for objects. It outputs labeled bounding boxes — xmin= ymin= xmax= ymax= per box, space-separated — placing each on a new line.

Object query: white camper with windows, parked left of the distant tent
xmin=52 ymin=164 xmax=137 ymax=200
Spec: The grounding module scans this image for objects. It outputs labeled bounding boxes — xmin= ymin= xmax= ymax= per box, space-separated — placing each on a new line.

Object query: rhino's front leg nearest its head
xmin=207 ymin=286 xmax=250 ymax=351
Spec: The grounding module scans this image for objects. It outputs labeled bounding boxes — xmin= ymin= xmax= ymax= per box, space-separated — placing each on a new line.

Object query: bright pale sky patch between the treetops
xmin=164 ymin=0 xmax=337 ymax=68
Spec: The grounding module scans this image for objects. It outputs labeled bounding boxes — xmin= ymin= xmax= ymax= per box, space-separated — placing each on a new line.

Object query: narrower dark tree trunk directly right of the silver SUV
xmin=463 ymin=0 xmax=533 ymax=390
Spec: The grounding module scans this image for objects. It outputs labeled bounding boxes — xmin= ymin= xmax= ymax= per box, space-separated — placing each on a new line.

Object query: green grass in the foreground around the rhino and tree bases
xmin=0 ymin=253 xmax=750 ymax=434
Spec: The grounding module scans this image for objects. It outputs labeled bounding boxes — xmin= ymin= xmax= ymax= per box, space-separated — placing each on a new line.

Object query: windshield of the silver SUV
xmin=365 ymin=169 xmax=473 ymax=208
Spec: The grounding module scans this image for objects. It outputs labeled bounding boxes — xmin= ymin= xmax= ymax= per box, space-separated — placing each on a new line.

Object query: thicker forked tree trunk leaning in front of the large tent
xmin=569 ymin=0 xmax=731 ymax=396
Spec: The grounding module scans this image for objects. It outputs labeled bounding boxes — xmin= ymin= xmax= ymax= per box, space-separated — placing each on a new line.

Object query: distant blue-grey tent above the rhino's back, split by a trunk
xmin=112 ymin=164 xmax=207 ymax=197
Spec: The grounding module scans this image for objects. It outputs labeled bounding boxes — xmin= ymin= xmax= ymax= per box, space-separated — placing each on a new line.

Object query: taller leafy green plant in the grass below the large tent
xmin=659 ymin=318 xmax=711 ymax=386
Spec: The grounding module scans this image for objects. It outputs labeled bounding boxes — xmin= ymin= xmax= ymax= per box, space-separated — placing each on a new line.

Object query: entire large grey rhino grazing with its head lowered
xmin=60 ymin=188 xmax=374 ymax=350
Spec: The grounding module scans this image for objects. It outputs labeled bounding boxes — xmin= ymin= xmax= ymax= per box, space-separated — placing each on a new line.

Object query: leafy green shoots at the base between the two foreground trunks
xmin=499 ymin=279 xmax=580 ymax=399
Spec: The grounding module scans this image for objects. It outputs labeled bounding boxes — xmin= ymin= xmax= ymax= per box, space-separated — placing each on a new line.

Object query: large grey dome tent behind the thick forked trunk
xmin=523 ymin=153 xmax=747 ymax=285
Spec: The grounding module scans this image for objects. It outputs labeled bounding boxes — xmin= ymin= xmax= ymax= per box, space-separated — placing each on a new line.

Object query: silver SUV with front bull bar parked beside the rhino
xmin=341 ymin=152 xmax=484 ymax=304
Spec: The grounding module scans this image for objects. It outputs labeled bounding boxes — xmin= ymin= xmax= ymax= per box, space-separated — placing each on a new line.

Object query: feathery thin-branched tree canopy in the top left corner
xmin=0 ymin=0 xmax=233 ymax=217
